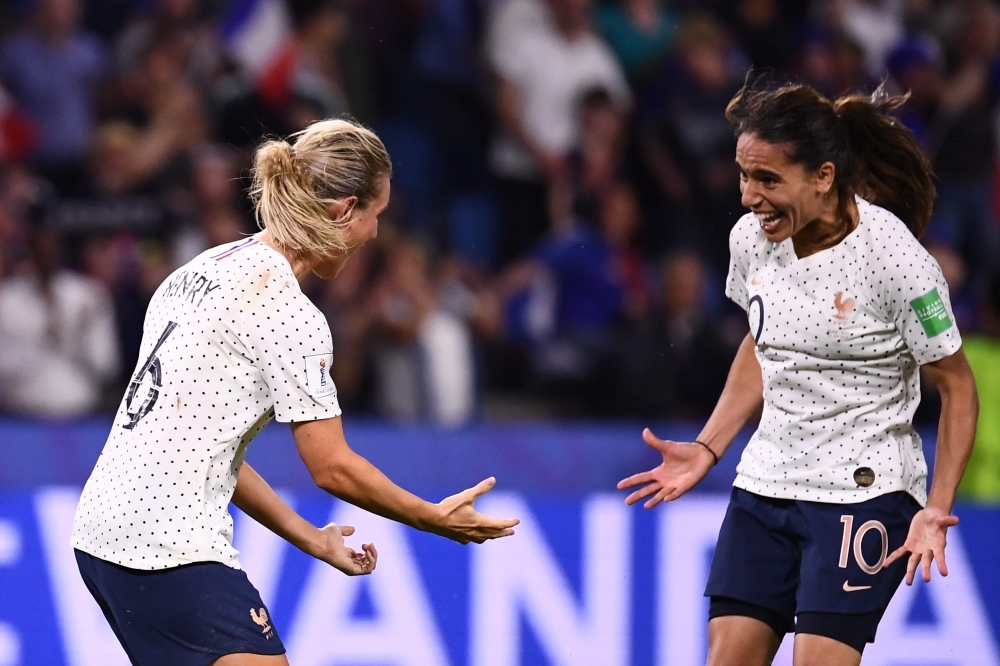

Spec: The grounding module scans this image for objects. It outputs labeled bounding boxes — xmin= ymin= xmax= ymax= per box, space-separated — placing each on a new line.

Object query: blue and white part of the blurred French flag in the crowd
xmin=222 ymin=0 xmax=292 ymax=82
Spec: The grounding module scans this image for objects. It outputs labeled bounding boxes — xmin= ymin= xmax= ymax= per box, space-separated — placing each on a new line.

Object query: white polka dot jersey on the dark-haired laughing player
xmin=726 ymin=198 xmax=962 ymax=505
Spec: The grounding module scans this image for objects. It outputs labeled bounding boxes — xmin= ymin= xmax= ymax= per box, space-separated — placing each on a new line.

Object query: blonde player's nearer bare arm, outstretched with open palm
xmin=292 ymin=417 xmax=520 ymax=543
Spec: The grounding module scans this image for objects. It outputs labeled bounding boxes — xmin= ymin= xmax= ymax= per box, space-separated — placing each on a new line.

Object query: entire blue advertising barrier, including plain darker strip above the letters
xmin=0 ymin=419 xmax=1000 ymax=666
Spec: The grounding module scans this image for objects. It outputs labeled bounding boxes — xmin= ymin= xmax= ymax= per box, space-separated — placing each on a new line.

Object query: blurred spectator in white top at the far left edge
xmin=0 ymin=223 xmax=118 ymax=418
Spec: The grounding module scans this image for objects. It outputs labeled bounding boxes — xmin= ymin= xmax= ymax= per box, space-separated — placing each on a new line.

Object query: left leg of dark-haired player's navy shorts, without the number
xmin=705 ymin=488 xmax=801 ymax=638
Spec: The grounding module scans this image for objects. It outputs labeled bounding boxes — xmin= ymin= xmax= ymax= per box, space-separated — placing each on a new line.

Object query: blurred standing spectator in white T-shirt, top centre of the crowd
xmin=490 ymin=0 xmax=630 ymax=261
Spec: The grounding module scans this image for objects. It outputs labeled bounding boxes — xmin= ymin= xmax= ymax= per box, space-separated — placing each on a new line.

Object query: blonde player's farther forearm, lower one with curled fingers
xmin=233 ymin=462 xmax=378 ymax=575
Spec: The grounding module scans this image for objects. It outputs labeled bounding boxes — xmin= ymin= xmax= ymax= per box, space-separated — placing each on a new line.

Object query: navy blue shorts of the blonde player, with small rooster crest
xmin=76 ymin=550 xmax=285 ymax=666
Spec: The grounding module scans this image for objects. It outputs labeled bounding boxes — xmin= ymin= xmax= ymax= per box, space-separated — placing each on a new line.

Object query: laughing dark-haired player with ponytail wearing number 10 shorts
xmin=619 ymin=85 xmax=978 ymax=666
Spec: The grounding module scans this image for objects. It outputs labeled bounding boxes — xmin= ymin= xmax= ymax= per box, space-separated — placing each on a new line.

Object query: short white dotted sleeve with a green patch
xmin=879 ymin=239 xmax=962 ymax=365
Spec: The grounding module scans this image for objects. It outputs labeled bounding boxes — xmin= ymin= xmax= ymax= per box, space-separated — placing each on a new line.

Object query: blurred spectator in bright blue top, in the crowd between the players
xmin=502 ymin=183 xmax=651 ymax=415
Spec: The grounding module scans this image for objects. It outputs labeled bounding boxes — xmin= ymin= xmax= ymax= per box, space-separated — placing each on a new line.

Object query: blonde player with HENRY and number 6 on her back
xmin=72 ymin=120 xmax=518 ymax=666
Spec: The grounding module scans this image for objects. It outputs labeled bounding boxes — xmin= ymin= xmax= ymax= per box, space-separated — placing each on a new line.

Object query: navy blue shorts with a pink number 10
xmin=705 ymin=488 xmax=920 ymax=646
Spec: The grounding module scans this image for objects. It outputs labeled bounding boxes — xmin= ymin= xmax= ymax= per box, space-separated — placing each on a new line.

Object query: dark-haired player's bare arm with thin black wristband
xmin=618 ymin=335 xmax=764 ymax=509
